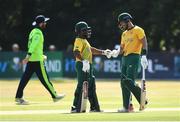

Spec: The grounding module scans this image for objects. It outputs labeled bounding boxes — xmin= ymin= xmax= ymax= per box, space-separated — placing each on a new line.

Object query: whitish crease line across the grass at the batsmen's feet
xmin=0 ymin=108 xmax=180 ymax=115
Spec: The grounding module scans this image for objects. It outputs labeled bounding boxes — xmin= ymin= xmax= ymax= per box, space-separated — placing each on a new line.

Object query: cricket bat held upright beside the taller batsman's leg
xmin=139 ymin=68 xmax=146 ymax=111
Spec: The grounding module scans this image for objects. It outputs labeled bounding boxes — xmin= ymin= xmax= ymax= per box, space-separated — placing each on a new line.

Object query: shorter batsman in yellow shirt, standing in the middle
xmin=71 ymin=21 xmax=111 ymax=113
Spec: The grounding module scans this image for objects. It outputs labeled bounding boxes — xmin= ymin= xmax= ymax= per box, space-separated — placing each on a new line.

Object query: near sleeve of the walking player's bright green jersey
xmin=28 ymin=33 xmax=41 ymax=53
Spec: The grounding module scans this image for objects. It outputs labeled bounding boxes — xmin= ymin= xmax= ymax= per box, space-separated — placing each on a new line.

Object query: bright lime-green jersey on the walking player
xmin=28 ymin=28 xmax=44 ymax=61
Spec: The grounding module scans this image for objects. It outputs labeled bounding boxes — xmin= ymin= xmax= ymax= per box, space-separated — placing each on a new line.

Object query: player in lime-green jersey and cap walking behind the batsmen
xmin=15 ymin=15 xmax=65 ymax=105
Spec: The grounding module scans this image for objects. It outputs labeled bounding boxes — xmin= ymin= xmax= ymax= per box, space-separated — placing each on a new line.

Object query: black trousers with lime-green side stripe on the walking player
xmin=16 ymin=61 xmax=57 ymax=98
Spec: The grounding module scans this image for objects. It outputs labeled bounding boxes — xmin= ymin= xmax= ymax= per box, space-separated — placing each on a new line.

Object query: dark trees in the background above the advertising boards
xmin=0 ymin=0 xmax=180 ymax=52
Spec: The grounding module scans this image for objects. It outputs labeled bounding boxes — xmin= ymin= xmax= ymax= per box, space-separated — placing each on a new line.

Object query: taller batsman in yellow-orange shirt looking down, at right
xmin=112 ymin=13 xmax=148 ymax=112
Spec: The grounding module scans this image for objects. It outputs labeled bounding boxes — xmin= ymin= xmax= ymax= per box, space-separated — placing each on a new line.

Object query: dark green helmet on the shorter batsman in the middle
xmin=75 ymin=21 xmax=91 ymax=38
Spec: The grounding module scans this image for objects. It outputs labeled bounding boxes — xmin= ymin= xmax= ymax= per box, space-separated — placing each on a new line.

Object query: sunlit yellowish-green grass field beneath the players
xmin=0 ymin=79 xmax=180 ymax=121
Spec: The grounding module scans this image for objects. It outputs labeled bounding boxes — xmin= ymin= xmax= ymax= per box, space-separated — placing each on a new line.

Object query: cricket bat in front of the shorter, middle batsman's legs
xmin=80 ymin=73 xmax=88 ymax=113
